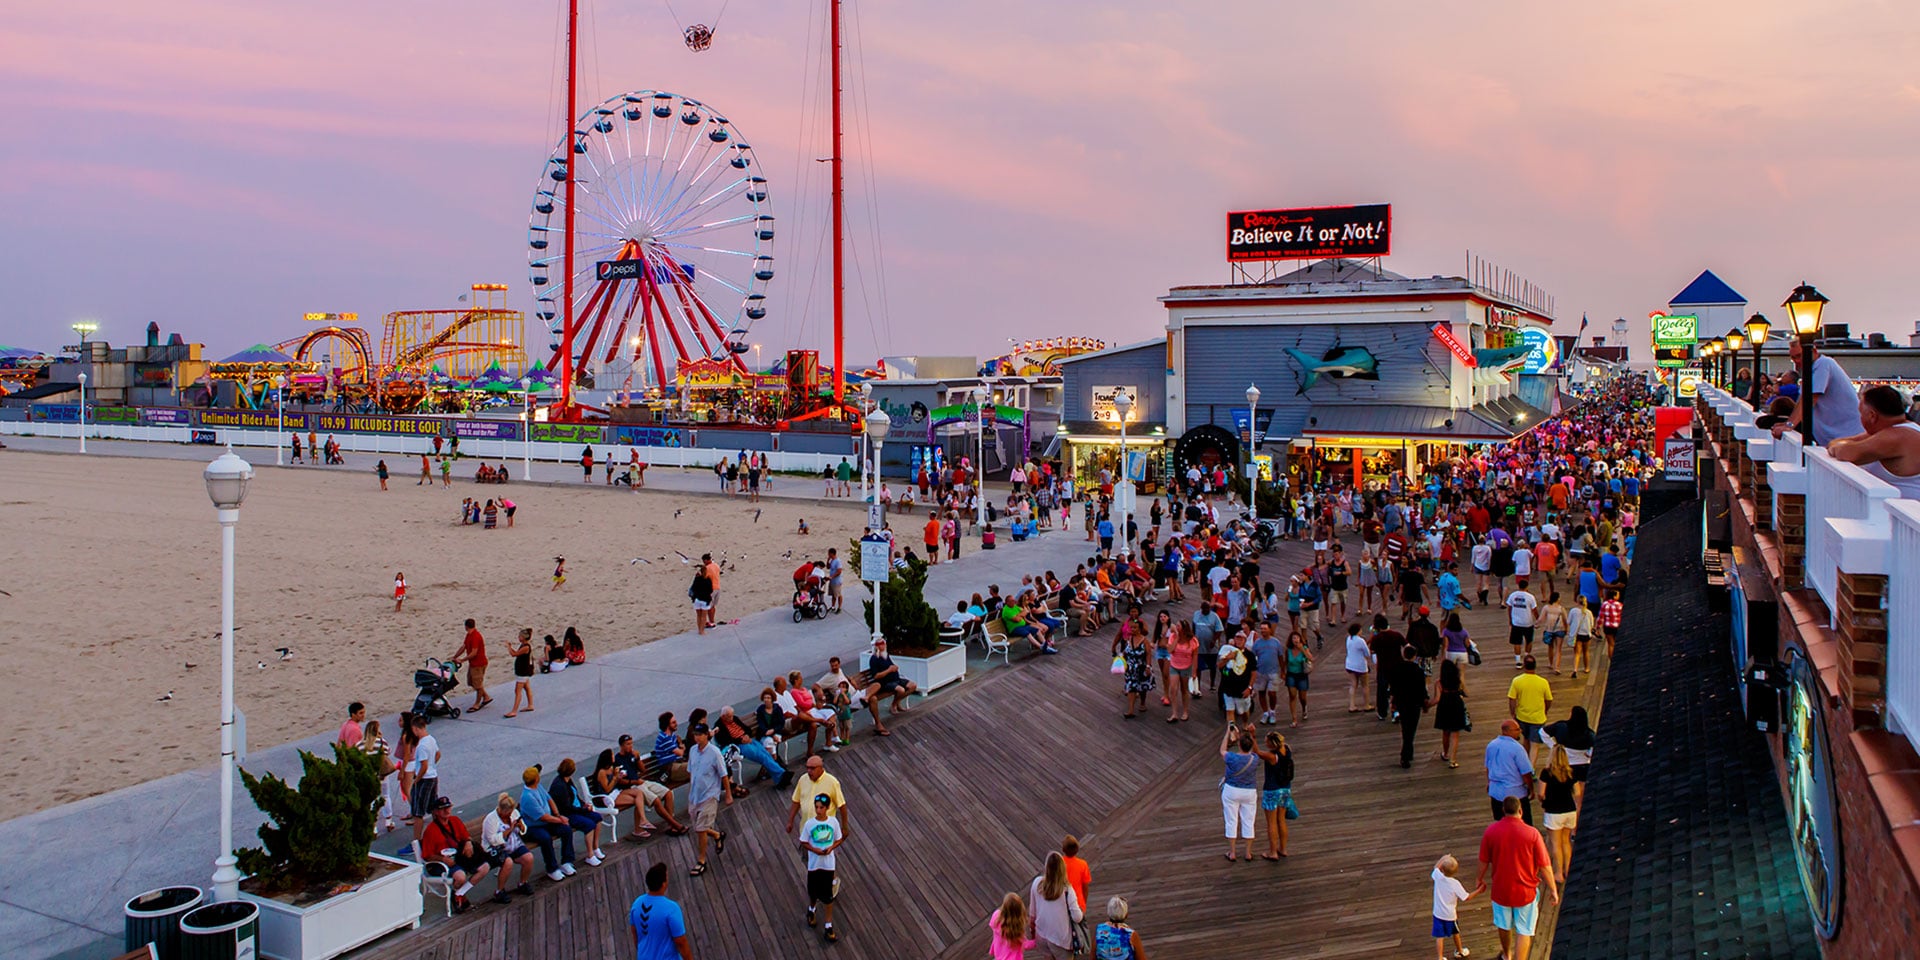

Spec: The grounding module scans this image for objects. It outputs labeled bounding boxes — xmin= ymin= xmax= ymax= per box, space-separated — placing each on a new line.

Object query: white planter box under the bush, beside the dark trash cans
xmin=240 ymin=852 xmax=424 ymax=960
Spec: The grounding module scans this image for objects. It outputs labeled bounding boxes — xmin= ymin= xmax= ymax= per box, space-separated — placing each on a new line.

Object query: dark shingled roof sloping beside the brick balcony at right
xmin=1553 ymin=506 xmax=1820 ymax=960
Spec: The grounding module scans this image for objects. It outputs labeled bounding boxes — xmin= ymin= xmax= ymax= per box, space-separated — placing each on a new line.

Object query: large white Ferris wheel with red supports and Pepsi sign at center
xmin=526 ymin=90 xmax=774 ymax=388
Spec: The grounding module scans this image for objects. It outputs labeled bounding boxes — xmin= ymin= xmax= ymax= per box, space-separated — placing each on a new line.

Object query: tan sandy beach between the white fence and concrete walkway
xmin=0 ymin=451 xmax=862 ymax=816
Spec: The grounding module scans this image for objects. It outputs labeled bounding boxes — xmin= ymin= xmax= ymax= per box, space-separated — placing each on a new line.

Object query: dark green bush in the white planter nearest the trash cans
xmin=236 ymin=743 xmax=380 ymax=891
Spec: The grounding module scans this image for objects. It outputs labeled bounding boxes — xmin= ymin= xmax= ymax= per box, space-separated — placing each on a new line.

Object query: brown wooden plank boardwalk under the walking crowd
xmin=361 ymin=543 xmax=1597 ymax=960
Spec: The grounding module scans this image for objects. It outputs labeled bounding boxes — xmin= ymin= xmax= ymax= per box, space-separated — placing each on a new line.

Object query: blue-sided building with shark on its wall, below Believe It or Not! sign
xmin=1060 ymin=259 xmax=1559 ymax=482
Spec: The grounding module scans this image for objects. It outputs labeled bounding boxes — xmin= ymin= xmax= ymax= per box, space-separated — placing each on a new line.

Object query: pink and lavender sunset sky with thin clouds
xmin=0 ymin=0 xmax=1920 ymax=361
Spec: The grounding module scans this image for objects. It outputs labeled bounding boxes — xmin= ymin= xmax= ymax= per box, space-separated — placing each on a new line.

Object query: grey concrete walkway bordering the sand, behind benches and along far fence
xmin=0 ymin=438 xmax=1091 ymax=958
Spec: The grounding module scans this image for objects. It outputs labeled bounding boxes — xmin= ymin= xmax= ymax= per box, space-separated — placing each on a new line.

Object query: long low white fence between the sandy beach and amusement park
xmin=0 ymin=420 xmax=858 ymax=474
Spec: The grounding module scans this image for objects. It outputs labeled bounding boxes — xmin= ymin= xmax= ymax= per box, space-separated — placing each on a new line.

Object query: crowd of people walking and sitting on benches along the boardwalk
xmin=318 ymin=376 xmax=1653 ymax=960
